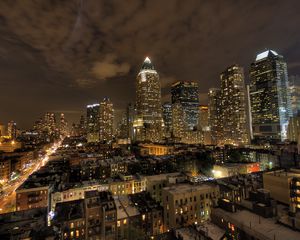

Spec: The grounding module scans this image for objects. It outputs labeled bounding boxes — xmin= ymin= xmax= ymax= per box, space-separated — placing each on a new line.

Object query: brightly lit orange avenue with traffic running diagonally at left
xmin=0 ymin=142 xmax=61 ymax=214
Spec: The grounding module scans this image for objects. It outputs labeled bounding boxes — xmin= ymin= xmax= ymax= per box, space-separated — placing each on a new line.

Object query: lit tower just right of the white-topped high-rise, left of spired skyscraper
xmin=99 ymin=98 xmax=114 ymax=142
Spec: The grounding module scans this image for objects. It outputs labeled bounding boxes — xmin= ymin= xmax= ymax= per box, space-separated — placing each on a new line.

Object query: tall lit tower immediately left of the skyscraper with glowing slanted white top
xmin=220 ymin=64 xmax=248 ymax=145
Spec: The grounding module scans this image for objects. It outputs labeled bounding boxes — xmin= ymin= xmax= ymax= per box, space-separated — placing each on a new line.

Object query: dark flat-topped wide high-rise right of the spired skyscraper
xmin=171 ymin=82 xmax=199 ymax=130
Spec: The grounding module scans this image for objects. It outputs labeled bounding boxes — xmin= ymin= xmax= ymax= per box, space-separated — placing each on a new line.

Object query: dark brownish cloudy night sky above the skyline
xmin=0 ymin=0 xmax=300 ymax=128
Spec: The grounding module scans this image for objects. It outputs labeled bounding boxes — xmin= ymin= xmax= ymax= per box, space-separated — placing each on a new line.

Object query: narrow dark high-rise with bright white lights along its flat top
xmin=86 ymin=103 xmax=100 ymax=142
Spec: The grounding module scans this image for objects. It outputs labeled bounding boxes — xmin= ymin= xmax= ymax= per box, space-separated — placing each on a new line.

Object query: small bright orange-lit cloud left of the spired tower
xmin=91 ymin=54 xmax=130 ymax=80
